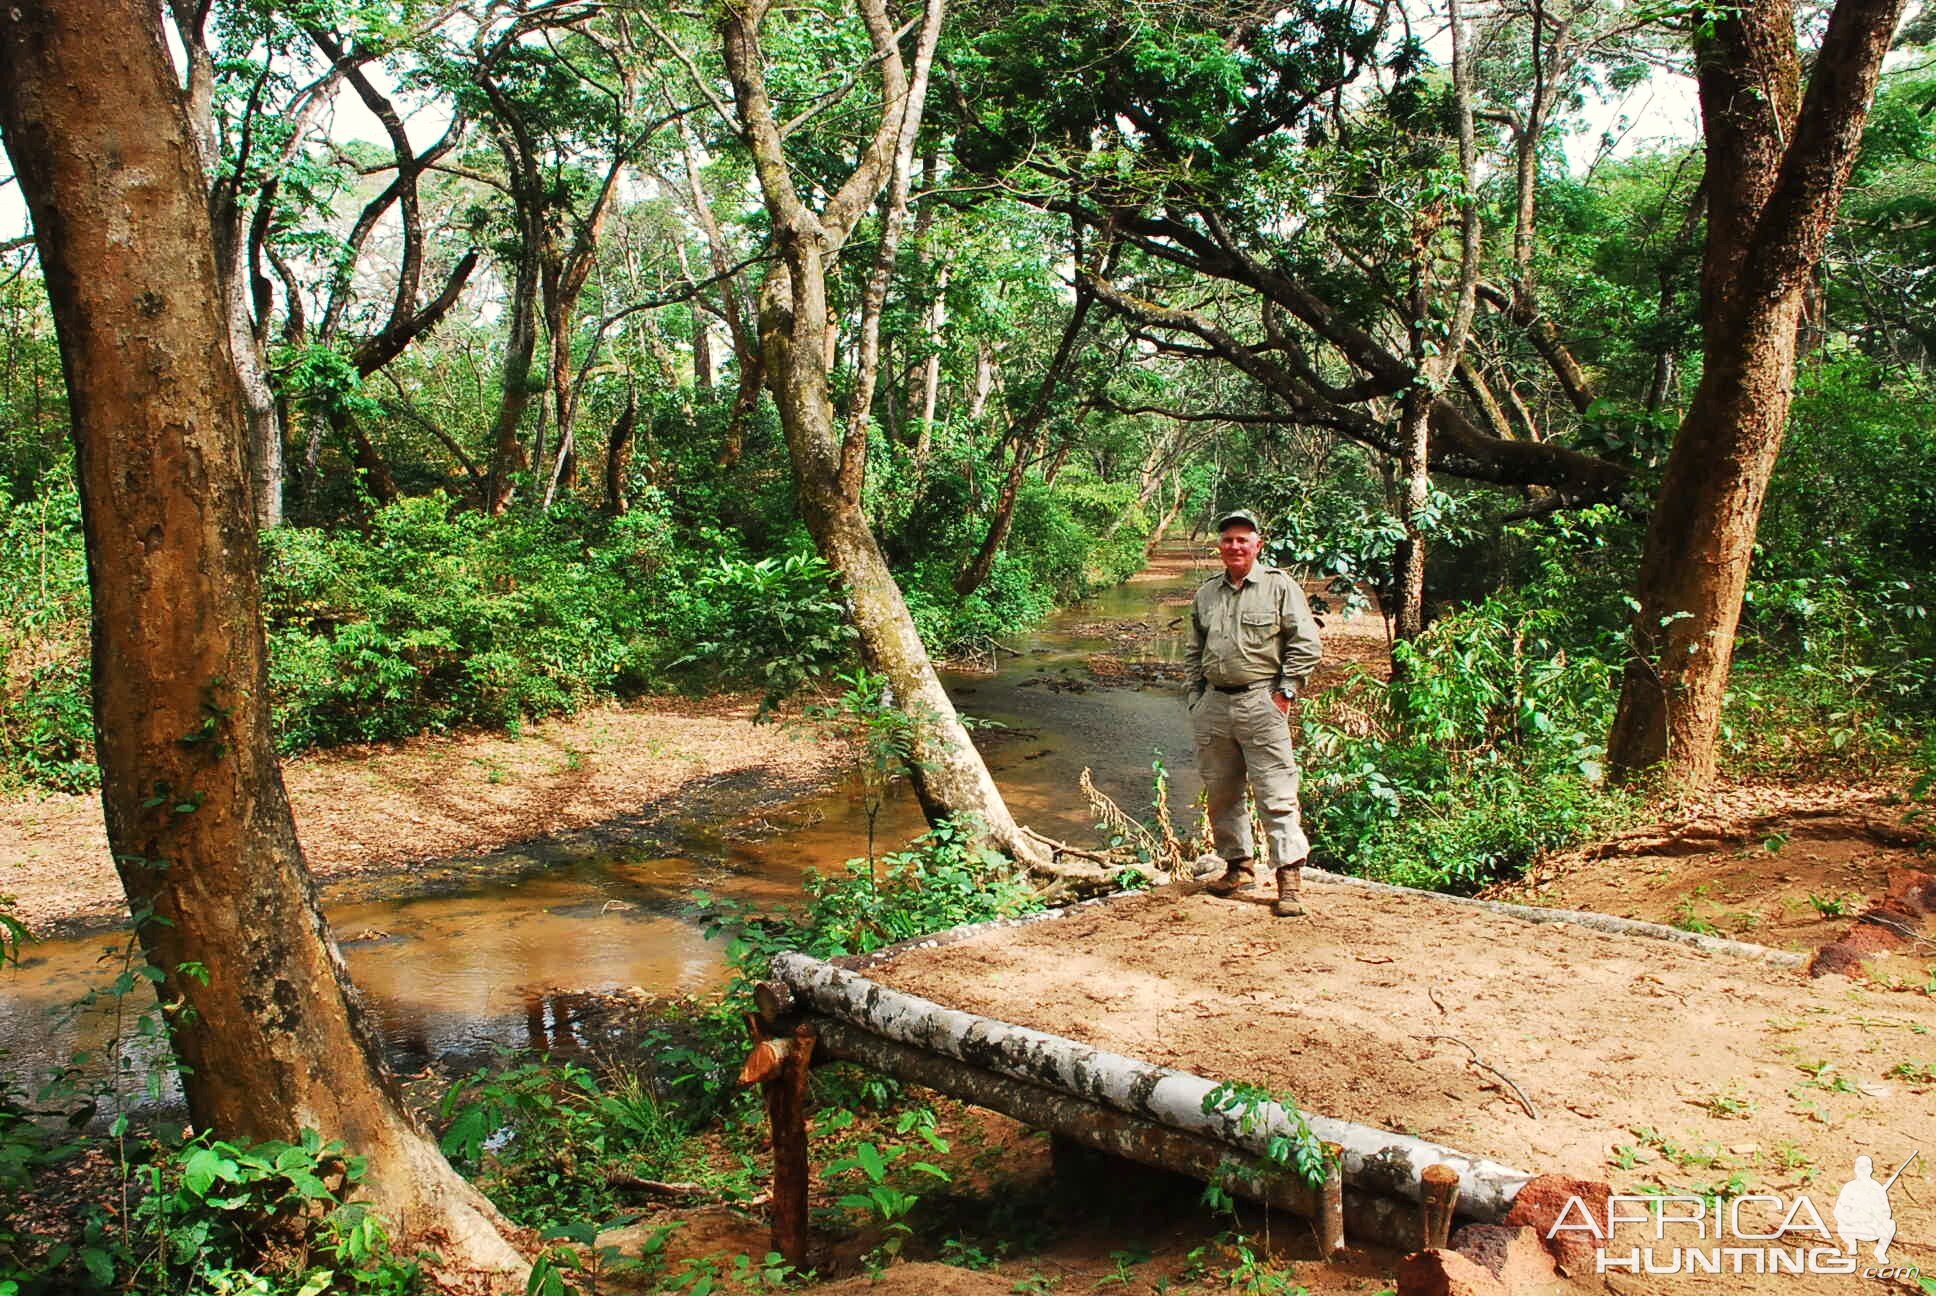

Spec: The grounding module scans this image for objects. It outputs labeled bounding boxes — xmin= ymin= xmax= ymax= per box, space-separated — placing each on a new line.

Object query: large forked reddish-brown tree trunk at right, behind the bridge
xmin=1609 ymin=0 xmax=1903 ymax=788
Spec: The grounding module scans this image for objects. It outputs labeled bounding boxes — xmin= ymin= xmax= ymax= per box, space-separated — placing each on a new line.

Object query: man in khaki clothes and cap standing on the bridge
xmin=1187 ymin=509 xmax=1320 ymax=918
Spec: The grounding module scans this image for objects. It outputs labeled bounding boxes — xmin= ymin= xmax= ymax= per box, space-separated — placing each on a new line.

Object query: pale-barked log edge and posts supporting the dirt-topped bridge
xmin=740 ymin=922 xmax=1531 ymax=1269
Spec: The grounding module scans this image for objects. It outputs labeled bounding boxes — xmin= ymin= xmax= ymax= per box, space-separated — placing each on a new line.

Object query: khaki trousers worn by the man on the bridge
xmin=1191 ymin=688 xmax=1311 ymax=868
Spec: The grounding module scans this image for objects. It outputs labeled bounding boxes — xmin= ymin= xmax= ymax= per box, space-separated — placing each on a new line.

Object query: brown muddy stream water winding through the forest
xmin=0 ymin=548 xmax=1212 ymax=1106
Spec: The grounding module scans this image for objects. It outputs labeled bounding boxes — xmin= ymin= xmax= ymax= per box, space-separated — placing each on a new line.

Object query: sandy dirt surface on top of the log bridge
xmin=871 ymin=885 xmax=1936 ymax=1292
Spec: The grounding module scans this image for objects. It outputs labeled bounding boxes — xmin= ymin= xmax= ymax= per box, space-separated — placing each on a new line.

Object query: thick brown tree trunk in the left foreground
xmin=0 ymin=0 xmax=525 ymax=1284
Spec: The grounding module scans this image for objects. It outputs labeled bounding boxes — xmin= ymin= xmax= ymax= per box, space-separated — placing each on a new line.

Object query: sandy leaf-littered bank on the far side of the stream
xmin=0 ymin=697 xmax=850 ymax=936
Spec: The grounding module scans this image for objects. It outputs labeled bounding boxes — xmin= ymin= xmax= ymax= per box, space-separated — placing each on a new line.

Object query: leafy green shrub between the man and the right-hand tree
xmin=1303 ymin=519 xmax=1634 ymax=891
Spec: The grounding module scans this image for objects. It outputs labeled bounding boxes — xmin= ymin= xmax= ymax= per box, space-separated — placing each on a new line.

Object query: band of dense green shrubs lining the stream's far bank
xmin=0 ymin=445 xmax=1146 ymax=790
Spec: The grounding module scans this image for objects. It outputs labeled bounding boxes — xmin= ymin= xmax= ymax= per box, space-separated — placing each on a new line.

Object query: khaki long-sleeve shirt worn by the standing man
xmin=1185 ymin=566 xmax=1322 ymax=697
